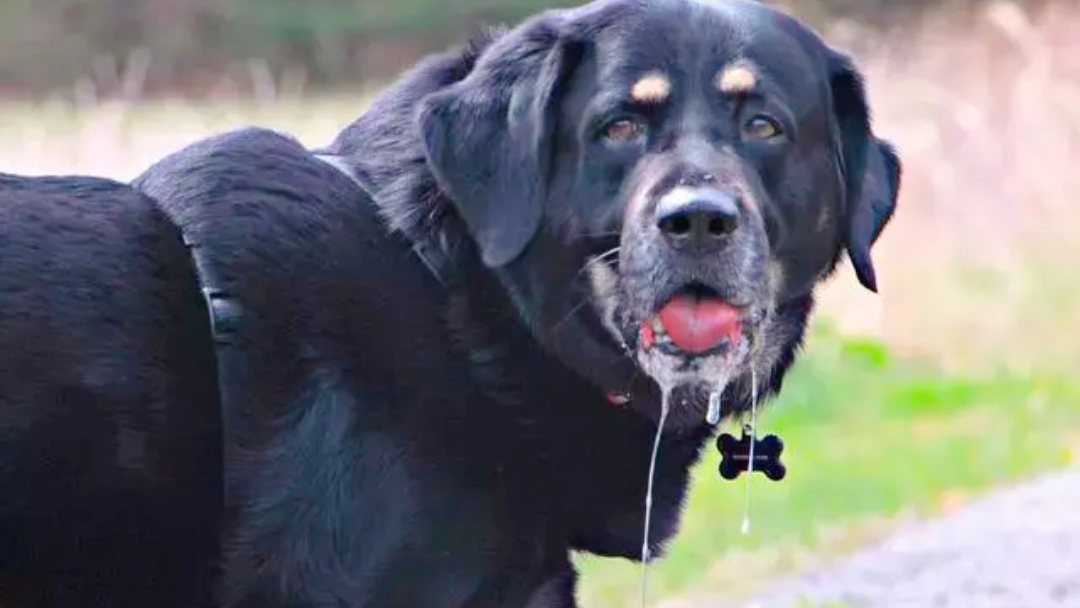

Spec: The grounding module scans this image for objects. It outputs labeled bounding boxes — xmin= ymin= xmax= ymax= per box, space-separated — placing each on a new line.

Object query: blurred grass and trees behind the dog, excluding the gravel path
xmin=0 ymin=0 xmax=1080 ymax=608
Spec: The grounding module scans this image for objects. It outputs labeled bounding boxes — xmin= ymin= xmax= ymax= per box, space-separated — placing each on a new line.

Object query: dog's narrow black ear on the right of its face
xmin=828 ymin=51 xmax=902 ymax=293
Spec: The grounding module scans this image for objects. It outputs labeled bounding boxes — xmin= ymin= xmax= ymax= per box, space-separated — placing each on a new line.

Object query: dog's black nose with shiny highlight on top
xmin=657 ymin=187 xmax=739 ymax=248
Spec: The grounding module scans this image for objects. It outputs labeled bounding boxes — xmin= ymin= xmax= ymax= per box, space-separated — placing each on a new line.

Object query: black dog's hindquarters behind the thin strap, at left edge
xmin=0 ymin=175 xmax=222 ymax=608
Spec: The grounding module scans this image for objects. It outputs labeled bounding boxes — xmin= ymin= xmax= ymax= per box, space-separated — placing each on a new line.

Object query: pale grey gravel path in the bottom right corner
xmin=742 ymin=469 xmax=1080 ymax=608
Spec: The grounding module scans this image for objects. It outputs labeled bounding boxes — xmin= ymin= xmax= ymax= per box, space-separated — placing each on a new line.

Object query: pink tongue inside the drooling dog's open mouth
xmin=660 ymin=295 xmax=742 ymax=353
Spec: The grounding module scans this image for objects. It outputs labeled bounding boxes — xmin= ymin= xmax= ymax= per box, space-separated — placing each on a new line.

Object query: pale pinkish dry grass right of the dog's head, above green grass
xmin=825 ymin=1 xmax=1080 ymax=375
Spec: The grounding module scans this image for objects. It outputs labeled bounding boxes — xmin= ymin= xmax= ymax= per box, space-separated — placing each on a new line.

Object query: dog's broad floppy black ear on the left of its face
xmin=418 ymin=16 xmax=579 ymax=268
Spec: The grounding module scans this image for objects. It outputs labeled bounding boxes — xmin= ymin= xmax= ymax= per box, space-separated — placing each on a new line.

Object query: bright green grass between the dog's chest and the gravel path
xmin=579 ymin=325 xmax=1080 ymax=608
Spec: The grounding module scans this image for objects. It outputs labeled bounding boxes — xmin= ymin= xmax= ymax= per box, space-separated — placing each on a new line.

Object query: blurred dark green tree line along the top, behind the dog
xmin=0 ymin=0 xmax=1006 ymax=96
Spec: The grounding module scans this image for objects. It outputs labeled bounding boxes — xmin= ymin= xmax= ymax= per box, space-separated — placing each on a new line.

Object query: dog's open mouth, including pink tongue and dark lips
xmin=638 ymin=283 xmax=747 ymax=360
